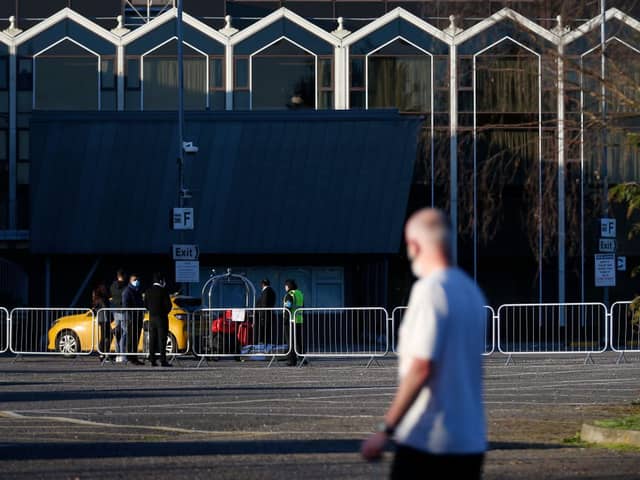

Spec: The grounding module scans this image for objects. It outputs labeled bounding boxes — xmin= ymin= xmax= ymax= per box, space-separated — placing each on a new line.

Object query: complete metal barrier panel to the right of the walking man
xmin=497 ymin=303 xmax=608 ymax=355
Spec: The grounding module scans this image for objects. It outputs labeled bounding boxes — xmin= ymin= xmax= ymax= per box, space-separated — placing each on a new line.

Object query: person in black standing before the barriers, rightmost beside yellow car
xmin=144 ymin=273 xmax=171 ymax=367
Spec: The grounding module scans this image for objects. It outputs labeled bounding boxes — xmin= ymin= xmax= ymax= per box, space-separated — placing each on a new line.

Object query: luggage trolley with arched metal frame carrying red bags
xmin=198 ymin=269 xmax=256 ymax=365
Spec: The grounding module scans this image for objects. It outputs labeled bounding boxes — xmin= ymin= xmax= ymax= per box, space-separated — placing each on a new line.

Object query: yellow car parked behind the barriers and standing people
xmin=47 ymin=296 xmax=200 ymax=355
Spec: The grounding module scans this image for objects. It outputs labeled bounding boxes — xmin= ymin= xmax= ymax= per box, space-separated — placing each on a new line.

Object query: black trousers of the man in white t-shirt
xmin=391 ymin=445 xmax=484 ymax=480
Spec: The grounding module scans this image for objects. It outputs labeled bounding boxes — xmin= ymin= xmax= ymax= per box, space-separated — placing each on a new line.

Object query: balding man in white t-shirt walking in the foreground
xmin=362 ymin=209 xmax=487 ymax=479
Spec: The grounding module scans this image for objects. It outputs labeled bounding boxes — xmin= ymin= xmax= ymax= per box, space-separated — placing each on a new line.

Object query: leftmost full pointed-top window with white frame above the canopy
xmin=34 ymin=41 xmax=98 ymax=110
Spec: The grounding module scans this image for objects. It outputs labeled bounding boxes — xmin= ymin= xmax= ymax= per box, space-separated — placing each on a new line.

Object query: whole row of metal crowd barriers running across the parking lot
xmin=0 ymin=302 xmax=640 ymax=364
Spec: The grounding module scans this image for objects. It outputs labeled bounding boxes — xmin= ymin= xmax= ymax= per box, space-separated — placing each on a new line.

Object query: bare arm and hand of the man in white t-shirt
xmin=361 ymin=358 xmax=433 ymax=460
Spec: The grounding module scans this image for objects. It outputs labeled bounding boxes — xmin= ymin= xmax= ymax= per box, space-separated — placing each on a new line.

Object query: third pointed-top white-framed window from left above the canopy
xmin=251 ymin=40 xmax=316 ymax=109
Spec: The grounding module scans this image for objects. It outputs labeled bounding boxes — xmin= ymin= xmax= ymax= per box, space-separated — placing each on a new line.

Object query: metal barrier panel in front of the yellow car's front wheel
xmin=9 ymin=308 xmax=94 ymax=355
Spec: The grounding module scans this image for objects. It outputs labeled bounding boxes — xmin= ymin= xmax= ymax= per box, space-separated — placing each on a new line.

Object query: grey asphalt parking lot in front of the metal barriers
xmin=0 ymin=354 xmax=640 ymax=480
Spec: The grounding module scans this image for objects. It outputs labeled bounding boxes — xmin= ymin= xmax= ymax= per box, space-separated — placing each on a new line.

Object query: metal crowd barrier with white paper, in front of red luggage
xmin=189 ymin=308 xmax=292 ymax=365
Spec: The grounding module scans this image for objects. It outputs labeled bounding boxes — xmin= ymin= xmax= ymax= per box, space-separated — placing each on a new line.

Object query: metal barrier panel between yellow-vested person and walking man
xmin=295 ymin=308 xmax=389 ymax=357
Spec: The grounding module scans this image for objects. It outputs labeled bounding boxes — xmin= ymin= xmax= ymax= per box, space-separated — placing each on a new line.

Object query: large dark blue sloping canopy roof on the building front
xmin=31 ymin=111 xmax=421 ymax=254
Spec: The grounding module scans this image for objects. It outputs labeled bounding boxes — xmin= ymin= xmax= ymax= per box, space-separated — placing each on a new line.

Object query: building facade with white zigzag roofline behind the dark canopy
xmin=0 ymin=0 xmax=640 ymax=304
